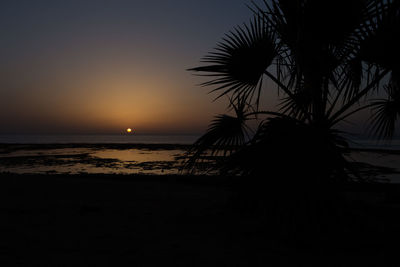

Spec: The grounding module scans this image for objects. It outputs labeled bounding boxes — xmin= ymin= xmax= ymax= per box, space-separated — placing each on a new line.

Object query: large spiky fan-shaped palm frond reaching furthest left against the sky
xmin=190 ymin=16 xmax=277 ymax=104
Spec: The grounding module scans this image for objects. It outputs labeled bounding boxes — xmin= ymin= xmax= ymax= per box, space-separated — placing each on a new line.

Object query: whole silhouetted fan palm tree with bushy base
xmin=187 ymin=0 xmax=400 ymax=182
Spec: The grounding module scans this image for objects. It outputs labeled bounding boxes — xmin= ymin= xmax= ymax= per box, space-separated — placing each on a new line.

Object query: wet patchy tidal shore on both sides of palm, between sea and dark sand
xmin=0 ymin=143 xmax=400 ymax=183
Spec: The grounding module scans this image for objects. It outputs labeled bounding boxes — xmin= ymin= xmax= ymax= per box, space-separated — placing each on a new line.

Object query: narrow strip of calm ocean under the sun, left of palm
xmin=0 ymin=134 xmax=199 ymax=144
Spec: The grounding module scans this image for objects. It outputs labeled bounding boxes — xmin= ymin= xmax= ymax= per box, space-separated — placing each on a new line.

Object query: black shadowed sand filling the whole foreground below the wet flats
xmin=0 ymin=174 xmax=400 ymax=266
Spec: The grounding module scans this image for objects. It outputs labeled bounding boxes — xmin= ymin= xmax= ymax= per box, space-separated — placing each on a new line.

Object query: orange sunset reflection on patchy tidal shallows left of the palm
xmin=0 ymin=147 xmax=185 ymax=174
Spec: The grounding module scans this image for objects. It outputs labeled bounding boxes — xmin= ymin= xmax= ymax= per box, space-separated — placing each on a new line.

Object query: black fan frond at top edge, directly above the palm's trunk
xmin=256 ymin=0 xmax=376 ymax=72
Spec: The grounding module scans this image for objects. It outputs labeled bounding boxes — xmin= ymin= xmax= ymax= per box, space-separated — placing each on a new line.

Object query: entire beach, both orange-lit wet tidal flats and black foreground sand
xmin=0 ymin=143 xmax=400 ymax=267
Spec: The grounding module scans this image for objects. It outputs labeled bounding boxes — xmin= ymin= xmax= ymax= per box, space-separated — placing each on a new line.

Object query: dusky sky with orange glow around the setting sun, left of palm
xmin=0 ymin=0 xmax=252 ymax=134
